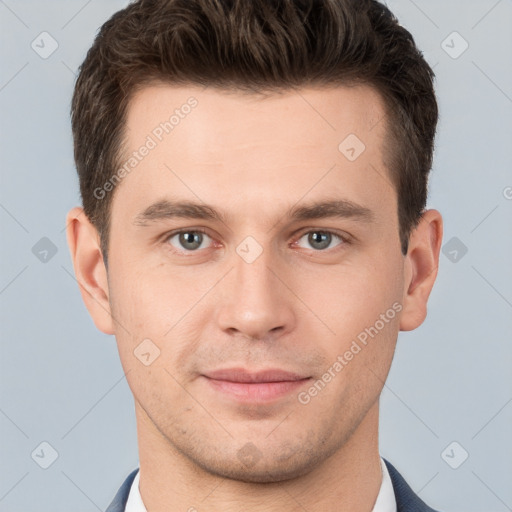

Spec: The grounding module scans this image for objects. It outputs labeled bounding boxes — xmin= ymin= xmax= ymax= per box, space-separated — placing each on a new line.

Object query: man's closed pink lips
xmin=203 ymin=368 xmax=311 ymax=403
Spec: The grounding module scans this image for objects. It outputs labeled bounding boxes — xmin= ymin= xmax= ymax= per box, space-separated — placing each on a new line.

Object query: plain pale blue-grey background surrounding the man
xmin=0 ymin=0 xmax=512 ymax=512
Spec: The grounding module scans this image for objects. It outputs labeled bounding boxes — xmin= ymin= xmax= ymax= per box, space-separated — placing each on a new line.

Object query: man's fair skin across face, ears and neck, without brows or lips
xmin=67 ymin=84 xmax=442 ymax=512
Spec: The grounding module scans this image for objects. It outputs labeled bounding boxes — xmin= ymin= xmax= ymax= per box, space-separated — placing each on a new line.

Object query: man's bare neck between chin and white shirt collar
xmin=135 ymin=402 xmax=382 ymax=512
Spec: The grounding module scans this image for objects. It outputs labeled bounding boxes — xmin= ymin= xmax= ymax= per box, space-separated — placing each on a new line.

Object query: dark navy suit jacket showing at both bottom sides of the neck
xmin=105 ymin=459 xmax=436 ymax=512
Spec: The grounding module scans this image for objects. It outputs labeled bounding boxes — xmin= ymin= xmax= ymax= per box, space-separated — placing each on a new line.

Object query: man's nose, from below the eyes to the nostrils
xmin=217 ymin=247 xmax=297 ymax=341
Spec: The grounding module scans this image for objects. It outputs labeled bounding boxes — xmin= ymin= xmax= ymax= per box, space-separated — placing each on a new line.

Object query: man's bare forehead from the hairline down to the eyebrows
xmin=114 ymin=84 xmax=394 ymax=224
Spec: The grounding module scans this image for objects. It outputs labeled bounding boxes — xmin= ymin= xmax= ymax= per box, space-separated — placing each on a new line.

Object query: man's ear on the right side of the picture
xmin=400 ymin=210 xmax=443 ymax=331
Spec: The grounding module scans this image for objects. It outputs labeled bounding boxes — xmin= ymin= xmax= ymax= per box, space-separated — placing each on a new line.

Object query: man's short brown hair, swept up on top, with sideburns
xmin=71 ymin=0 xmax=438 ymax=263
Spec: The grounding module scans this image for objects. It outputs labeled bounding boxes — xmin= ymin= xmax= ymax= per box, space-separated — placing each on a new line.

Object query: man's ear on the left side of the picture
xmin=66 ymin=207 xmax=114 ymax=334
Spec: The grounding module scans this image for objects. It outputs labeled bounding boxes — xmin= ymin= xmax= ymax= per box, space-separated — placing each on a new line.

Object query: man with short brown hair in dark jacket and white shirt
xmin=67 ymin=0 xmax=442 ymax=512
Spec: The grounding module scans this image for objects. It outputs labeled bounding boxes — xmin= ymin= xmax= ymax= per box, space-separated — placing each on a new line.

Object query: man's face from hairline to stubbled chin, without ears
xmin=108 ymin=86 xmax=404 ymax=481
